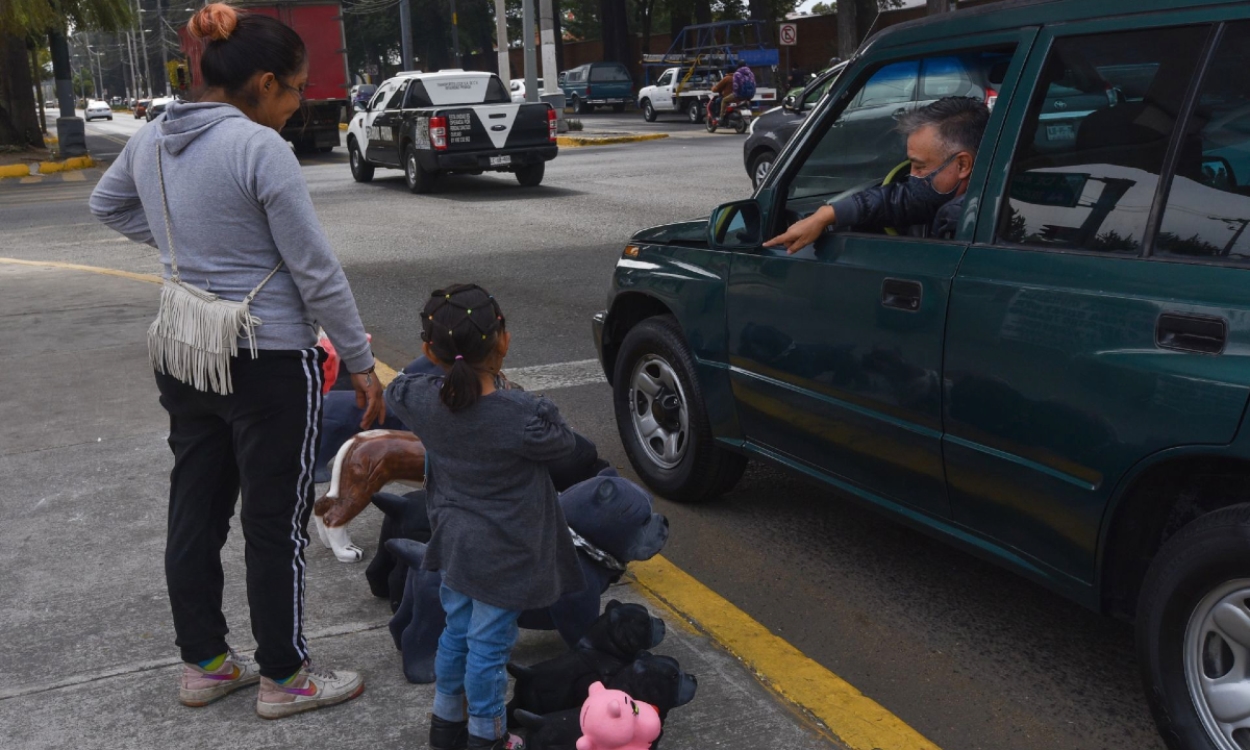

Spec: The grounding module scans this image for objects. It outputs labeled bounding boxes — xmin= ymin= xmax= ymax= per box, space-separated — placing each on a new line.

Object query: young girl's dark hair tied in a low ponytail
xmin=421 ymin=284 xmax=504 ymax=413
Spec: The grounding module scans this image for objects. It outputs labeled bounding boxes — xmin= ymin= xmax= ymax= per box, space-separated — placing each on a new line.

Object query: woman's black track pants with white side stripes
xmin=156 ymin=349 xmax=324 ymax=679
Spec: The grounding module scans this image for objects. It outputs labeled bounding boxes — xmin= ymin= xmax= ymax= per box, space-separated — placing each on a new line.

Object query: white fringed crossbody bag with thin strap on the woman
xmin=148 ymin=143 xmax=283 ymax=395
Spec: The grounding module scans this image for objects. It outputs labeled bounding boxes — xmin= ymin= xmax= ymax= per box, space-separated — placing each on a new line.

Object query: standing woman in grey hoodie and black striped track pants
xmin=91 ymin=4 xmax=385 ymax=719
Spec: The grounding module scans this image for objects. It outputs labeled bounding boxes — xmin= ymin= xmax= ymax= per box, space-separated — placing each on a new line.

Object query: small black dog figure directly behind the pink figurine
xmin=513 ymin=651 xmax=699 ymax=750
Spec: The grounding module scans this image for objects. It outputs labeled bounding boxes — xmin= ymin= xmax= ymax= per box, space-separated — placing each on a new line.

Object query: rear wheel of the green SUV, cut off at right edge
xmin=1136 ymin=504 xmax=1250 ymax=750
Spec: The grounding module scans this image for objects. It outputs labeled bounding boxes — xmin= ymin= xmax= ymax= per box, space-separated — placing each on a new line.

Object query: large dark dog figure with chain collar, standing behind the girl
xmin=385 ymin=469 xmax=669 ymax=684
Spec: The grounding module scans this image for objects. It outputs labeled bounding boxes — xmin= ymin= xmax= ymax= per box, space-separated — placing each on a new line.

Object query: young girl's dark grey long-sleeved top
xmin=386 ymin=374 xmax=585 ymax=610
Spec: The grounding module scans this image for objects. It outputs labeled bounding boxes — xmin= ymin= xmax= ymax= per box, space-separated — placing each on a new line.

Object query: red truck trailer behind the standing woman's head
xmin=179 ymin=0 xmax=349 ymax=153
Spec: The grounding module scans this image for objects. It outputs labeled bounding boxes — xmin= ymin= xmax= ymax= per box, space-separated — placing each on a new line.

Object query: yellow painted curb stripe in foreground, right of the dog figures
xmin=629 ymin=556 xmax=938 ymax=750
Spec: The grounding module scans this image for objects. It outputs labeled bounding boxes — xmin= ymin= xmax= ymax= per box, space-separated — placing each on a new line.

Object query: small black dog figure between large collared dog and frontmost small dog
xmin=508 ymin=599 xmax=664 ymax=715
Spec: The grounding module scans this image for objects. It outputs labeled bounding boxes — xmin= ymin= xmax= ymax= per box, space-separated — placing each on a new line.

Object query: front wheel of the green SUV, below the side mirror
xmin=613 ymin=315 xmax=746 ymax=503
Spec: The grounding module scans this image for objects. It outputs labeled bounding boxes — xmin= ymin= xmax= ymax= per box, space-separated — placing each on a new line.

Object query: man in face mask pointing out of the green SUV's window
xmin=764 ymin=96 xmax=990 ymax=253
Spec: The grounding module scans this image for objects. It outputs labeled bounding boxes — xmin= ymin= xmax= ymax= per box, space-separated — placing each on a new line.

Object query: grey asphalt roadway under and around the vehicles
xmin=0 ymin=108 xmax=1163 ymax=750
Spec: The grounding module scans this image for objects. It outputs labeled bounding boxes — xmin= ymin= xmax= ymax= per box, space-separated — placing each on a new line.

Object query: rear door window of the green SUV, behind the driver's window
xmin=999 ymin=26 xmax=1209 ymax=255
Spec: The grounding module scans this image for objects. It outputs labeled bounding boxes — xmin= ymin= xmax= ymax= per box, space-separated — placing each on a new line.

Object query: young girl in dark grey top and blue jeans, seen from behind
xmin=386 ymin=285 xmax=585 ymax=750
